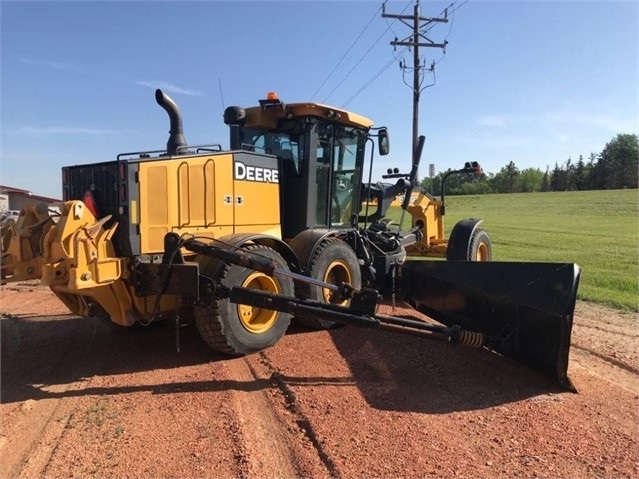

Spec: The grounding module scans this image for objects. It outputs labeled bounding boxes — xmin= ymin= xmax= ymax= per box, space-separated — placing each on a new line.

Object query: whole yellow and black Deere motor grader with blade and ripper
xmin=1 ymin=90 xmax=580 ymax=391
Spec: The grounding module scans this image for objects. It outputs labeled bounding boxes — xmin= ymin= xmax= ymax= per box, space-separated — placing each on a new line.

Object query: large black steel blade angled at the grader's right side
xmin=401 ymin=260 xmax=580 ymax=392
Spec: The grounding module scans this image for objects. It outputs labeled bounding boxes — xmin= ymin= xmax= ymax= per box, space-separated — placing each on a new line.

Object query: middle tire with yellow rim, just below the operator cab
xmin=295 ymin=238 xmax=362 ymax=329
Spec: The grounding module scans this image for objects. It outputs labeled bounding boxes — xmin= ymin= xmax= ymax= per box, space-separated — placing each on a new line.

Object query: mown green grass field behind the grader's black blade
xmin=389 ymin=190 xmax=639 ymax=311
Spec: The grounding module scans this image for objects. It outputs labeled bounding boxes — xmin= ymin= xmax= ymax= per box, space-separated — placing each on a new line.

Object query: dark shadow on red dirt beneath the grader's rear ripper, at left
xmin=0 ymin=314 xmax=241 ymax=403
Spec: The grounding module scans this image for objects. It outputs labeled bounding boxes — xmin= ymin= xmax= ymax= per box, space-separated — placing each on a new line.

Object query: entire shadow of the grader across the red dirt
xmin=0 ymin=314 xmax=562 ymax=414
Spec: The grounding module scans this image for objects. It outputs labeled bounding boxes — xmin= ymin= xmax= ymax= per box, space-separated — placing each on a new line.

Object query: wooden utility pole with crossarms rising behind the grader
xmin=382 ymin=0 xmax=448 ymax=162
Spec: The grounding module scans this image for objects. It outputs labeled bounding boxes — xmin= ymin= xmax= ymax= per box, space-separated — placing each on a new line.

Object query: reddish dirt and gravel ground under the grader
xmin=0 ymin=283 xmax=639 ymax=478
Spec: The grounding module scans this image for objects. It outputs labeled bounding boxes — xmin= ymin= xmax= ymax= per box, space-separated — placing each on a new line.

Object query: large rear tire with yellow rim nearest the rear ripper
xmin=193 ymin=245 xmax=294 ymax=356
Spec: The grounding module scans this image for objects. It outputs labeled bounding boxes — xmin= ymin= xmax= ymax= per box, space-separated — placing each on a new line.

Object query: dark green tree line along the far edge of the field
xmin=421 ymin=134 xmax=639 ymax=196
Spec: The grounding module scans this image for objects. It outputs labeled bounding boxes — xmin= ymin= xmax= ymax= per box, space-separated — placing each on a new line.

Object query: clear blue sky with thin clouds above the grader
xmin=0 ymin=0 xmax=639 ymax=198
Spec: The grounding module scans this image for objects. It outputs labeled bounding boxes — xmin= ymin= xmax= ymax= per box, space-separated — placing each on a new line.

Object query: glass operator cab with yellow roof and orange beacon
xmin=225 ymin=93 xmax=387 ymax=238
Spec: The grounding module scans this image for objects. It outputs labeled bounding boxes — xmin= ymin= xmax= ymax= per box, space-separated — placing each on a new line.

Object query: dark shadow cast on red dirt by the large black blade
xmin=330 ymin=320 xmax=572 ymax=414
